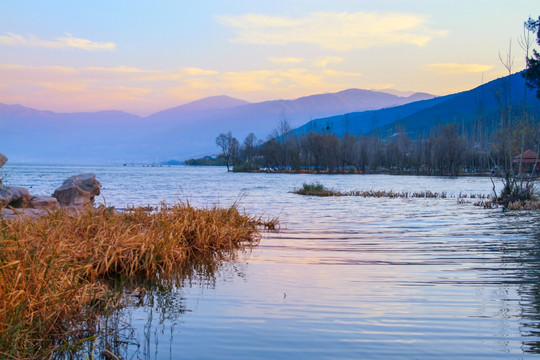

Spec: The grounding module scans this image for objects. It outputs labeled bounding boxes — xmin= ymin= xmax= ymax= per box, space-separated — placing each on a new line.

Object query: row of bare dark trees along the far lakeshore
xmin=216 ymin=111 xmax=539 ymax=176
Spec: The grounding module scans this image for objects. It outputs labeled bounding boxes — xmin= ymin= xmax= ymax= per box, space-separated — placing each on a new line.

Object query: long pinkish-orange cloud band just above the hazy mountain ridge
xmin=0 ymin=58 xmax=368 ymax=114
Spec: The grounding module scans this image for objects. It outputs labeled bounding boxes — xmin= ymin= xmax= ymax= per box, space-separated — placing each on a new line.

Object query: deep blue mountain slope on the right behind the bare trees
xmin=292 ymin=73 xmax=540 ymax=138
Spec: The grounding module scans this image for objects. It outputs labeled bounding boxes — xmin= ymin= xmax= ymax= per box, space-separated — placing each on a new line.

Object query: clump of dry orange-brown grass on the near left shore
xmin=0 ymin=204 xmax=277 ymax=359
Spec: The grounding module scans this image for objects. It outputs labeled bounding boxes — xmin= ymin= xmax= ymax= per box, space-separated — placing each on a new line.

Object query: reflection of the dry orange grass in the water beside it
xmin=60 ymin=256 xmax=234 ymax=359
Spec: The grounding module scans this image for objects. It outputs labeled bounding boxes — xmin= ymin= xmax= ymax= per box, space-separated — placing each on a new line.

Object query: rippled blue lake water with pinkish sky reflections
xmin=2 ymin=163 xmax=540 ymax=359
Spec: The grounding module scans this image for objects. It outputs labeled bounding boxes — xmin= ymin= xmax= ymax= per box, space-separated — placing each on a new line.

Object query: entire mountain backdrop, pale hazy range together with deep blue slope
xmin=4 ymin=73 xmax=540 ymax=164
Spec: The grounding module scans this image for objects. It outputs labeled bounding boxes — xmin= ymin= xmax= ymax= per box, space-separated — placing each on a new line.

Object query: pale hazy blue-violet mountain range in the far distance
xmin=0 ymin=89 xmax=434 ymax=164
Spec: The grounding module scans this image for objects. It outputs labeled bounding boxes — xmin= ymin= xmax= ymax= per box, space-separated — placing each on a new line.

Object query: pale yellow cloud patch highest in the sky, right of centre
xmin=216 ymin=11 xmax=447 ymax=51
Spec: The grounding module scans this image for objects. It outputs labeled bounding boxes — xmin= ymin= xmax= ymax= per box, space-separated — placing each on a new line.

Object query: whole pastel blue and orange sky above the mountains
xmin=0 ymin=0 xmax=540 ymax=115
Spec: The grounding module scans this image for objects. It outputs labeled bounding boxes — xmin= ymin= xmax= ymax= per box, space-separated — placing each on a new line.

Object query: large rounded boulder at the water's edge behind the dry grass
xmin=52 ymin=174 xmax=101 ymax=207
